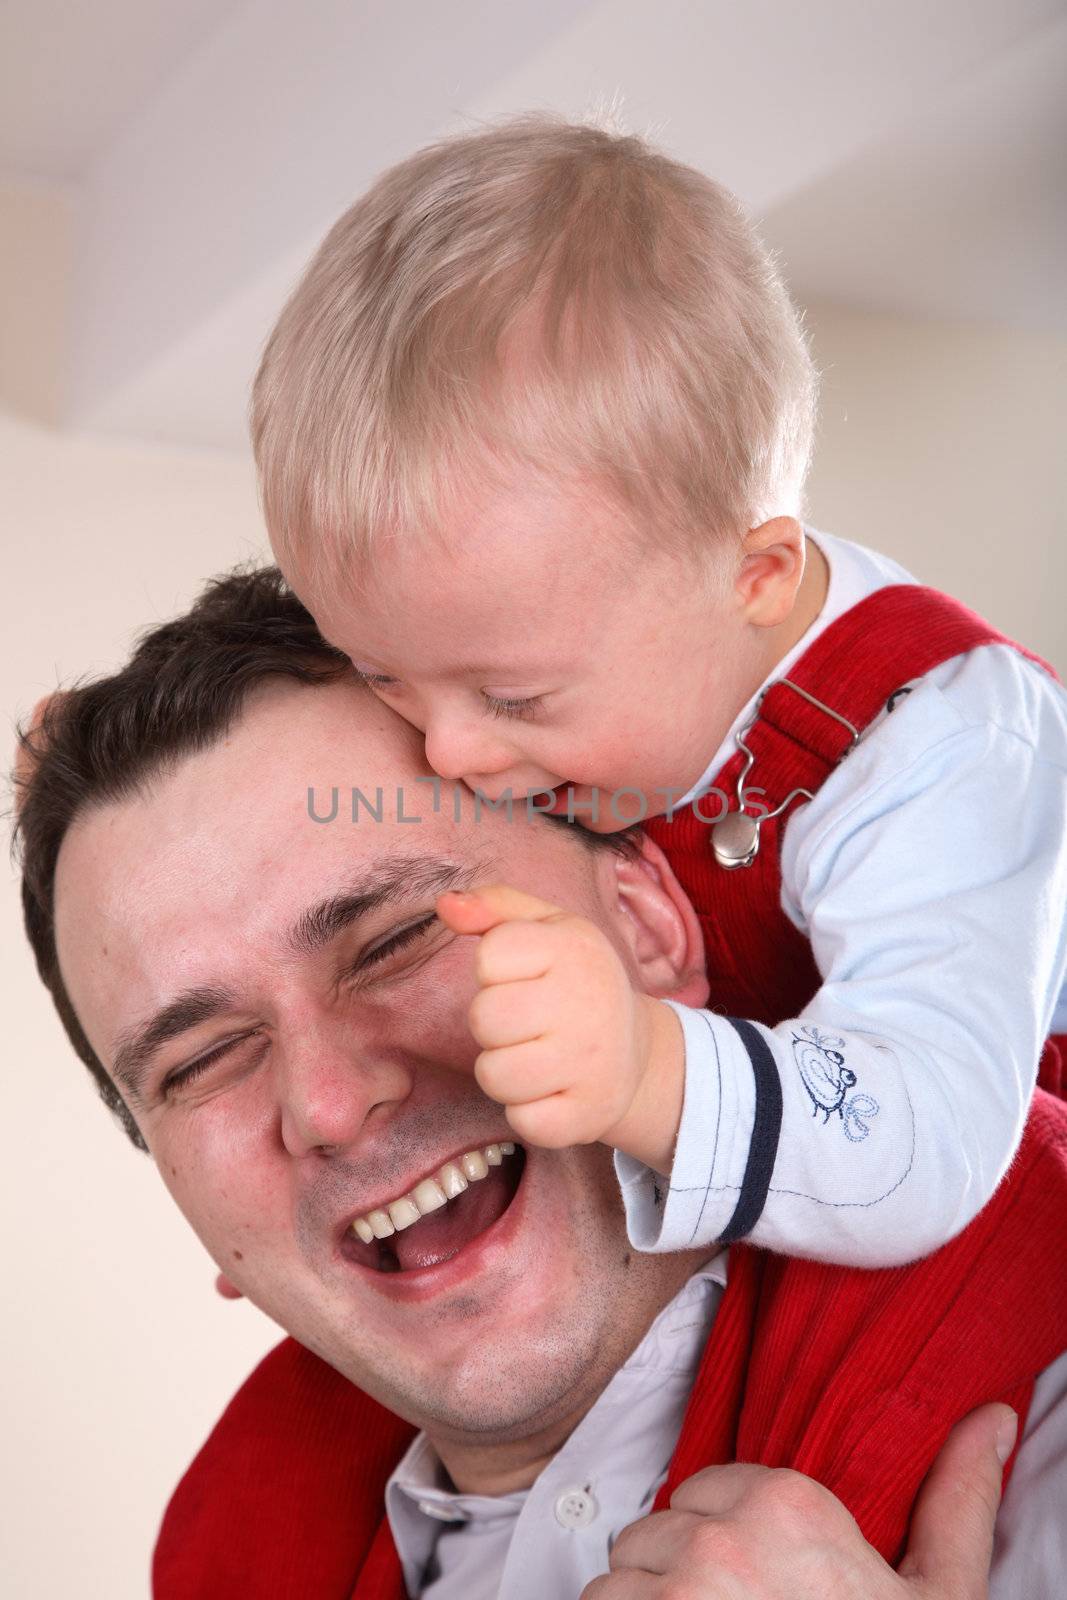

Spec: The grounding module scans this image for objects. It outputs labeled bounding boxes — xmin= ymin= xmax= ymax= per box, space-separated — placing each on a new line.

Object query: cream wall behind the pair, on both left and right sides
xmin=0 ymin=196 xmax=1067 ymax=1600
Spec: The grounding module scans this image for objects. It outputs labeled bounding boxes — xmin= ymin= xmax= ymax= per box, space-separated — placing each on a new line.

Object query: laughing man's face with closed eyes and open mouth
xmin=56 ymin=682 xmax=710 ymax=1440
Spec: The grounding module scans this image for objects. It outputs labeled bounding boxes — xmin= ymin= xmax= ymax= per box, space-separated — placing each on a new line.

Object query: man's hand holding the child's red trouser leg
xmin=581 ymin=1405 xmax=1017 ymax=1600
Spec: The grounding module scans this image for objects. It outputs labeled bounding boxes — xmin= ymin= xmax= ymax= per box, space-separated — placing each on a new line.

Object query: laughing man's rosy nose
xmin=278 ymin=1027 xmax=411 ymax=1157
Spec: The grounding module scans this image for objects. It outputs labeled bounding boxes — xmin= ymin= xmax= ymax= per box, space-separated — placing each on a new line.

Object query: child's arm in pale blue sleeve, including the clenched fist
xmin=441 ymin=653 xmax=1067 ymax=1266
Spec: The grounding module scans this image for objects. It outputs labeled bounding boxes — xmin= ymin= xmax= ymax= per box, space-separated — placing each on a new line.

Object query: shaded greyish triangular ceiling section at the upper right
xmin=766 ymin=21 xmax=1067 ymax=333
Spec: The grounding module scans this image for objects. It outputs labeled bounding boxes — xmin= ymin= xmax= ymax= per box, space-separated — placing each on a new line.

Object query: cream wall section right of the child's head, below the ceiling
xmin=808 ymin=306 xmax=1067 ymax=677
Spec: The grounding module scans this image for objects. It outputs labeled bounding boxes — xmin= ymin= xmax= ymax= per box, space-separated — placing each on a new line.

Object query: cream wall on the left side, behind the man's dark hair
xmin=0 ymin=414 xmax=278 ymax=1600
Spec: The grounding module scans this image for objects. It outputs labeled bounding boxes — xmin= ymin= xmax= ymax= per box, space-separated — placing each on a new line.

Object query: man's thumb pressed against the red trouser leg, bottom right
xmin=897 ymin=1405 xmax=1019 ymax=1600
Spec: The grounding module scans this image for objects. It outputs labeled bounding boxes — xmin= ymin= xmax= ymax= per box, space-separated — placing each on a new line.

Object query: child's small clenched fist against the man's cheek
xmin=437 ymin=883 xmax=683 ymax=1170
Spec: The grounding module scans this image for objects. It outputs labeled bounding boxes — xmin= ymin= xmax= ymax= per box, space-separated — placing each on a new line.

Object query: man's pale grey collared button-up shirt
xmin=386 ymin=1253 xmax=1067 ymax=1600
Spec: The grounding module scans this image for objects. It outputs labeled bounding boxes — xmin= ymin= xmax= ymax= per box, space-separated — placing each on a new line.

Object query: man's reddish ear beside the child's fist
xmin=614 ymin=832 xmax=707 ymax=1006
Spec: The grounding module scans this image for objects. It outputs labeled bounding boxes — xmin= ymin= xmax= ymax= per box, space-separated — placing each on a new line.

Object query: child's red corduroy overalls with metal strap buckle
xmin=154 ymin=586 xmax=1067 ymax=1600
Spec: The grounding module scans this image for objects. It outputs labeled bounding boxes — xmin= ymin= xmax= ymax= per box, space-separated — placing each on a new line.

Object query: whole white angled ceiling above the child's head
xmin=0 ymin=0 xmax=1067 ymax=448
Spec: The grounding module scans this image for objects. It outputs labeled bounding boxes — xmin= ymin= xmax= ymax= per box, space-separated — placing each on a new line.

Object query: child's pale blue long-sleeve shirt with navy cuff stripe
xmin=616 ymin=533 xmax=1067 ymax=1267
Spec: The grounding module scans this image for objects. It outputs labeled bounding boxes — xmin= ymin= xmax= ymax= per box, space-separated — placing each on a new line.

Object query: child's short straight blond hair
xmin=251 ymin=114 xmax=816 ymax=578
